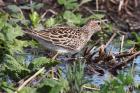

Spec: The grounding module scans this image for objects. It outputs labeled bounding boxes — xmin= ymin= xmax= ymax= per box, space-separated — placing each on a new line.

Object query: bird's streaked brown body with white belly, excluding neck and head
xmin=25 ymin=27 xmax=86 ymax=52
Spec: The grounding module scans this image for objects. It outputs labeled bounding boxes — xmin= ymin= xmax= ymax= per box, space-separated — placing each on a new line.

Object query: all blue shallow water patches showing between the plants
xmin=26 ymin=43 xmax=140 ymax=86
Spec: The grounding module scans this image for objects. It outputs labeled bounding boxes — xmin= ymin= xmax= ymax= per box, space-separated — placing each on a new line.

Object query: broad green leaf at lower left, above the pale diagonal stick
xmin=3 ymin=54 xmax=30 ymax=80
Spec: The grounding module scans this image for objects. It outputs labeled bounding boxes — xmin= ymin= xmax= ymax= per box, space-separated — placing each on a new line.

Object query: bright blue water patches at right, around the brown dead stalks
xmin=87 ymin=43 xmax=140 ymax=86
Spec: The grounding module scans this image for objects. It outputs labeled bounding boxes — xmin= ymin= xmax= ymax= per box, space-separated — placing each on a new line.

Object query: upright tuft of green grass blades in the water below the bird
xmin=66 ymin=62 xmax=86 ymax=93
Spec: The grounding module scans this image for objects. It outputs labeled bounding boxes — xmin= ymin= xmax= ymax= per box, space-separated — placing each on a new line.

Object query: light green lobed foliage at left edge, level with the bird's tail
xmin=0 ymin=23 xmax=28 ymax=54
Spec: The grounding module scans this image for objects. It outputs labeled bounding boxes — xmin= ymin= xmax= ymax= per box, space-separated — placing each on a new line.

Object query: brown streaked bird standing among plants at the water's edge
xmin=24 ymin=20 xmax=101 ymax=54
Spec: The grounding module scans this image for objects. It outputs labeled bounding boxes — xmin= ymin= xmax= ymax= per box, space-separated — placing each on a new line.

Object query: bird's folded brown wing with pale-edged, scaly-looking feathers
xmin=23 ymin=27 xmax=81 ymax=50
